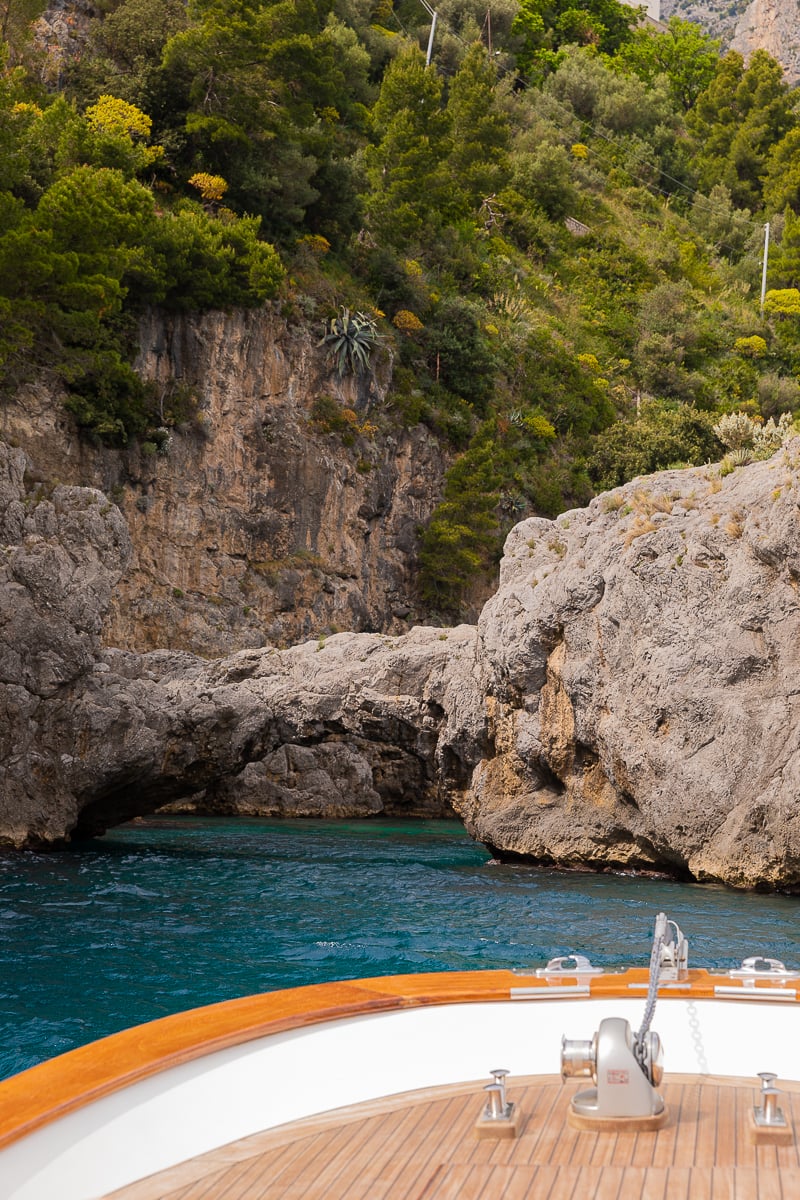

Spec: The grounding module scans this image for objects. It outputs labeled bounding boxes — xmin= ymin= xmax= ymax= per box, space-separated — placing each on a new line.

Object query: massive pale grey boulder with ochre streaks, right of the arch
xmin=461 ymin=443 xmax=800 ymax=887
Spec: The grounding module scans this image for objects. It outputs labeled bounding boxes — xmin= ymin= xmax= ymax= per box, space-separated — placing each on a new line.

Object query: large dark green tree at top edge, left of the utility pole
xmin=164 ymin=0 xmax=362 ymax=239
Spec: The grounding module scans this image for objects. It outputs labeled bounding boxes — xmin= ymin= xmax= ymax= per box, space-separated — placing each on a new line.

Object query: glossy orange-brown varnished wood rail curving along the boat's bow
xmin=0 ymin=968 xmax=796 ymax=1148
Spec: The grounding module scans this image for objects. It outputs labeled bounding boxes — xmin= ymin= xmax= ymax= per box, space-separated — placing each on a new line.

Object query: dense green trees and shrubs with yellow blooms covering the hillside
xmin=0 ymin=0 xmax=800 ymax=612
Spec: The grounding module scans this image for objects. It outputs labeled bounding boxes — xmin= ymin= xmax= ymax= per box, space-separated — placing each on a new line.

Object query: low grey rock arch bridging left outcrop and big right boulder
xmin=38 ymin=626 xmax=477 ymax=839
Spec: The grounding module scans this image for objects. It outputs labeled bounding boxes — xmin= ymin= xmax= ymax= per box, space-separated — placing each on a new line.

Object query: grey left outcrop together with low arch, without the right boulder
xmin=0 ymin=443 xmax=472 ymax=846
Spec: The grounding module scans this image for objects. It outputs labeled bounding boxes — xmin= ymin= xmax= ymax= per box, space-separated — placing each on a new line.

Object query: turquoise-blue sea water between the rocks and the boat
xmin=0 ymin=818 xmax=800 ymax=1078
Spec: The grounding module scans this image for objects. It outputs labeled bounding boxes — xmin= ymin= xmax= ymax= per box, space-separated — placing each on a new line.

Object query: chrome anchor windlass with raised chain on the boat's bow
xmin=561 ymin=912 xmax=688 ymax=1124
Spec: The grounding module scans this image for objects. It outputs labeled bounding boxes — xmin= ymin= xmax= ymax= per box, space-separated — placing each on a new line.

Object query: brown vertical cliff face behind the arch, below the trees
xmin=0 ymin=310 xmax=446 ymax=656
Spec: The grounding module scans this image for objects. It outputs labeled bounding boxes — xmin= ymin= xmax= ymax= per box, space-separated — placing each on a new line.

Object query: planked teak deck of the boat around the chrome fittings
xmin=109 ymin=1075 xmax=800 ymax=1200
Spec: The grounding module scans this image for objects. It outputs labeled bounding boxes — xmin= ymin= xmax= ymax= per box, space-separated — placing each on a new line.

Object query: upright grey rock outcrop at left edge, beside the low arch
xmin=0 ymin=442 xmax=131 ymax=845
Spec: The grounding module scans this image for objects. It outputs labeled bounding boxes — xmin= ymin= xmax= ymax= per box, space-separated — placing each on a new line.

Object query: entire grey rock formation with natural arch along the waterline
xmin=0 ymin=443 xmax=800 ymax=889
